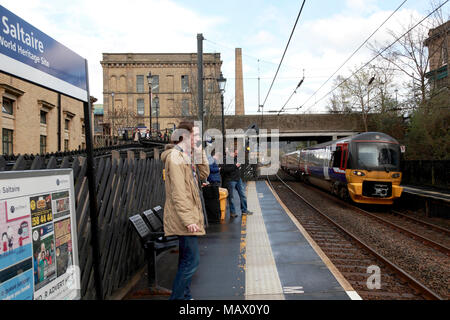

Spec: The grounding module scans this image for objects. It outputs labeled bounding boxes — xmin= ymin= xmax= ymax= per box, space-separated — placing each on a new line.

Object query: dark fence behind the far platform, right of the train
xmin=401 ymin=160 xmax=450 ymax=190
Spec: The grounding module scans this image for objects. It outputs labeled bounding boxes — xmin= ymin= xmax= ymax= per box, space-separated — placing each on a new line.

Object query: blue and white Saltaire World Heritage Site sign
xmin=0 ymin=6 xmax=87 ymax=101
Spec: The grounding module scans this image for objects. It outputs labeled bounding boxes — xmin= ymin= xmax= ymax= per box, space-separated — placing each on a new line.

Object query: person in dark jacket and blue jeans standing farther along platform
xmin=222 ymin=150 xmax=253 ymax=218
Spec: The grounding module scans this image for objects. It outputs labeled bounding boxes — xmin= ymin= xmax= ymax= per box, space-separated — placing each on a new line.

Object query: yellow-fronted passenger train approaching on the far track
xmin=280 ymin=132 xmax=403 ymax=205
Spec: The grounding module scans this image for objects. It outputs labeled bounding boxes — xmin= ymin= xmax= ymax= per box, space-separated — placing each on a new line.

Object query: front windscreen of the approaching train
xmin=356 ymin=142 xmax=400 ymax=171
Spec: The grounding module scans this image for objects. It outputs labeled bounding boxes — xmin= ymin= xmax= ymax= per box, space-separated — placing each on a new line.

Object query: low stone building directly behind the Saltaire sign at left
xmin=0 ymin=72 xmax=89 ymax=154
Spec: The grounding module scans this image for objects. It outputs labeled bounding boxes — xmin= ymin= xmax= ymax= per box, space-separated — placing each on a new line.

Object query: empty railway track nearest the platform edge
xmin=267 ymin=175 xmax=442 ymax=300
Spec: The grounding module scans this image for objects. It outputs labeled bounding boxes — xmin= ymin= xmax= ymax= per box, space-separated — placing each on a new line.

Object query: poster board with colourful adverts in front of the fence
xmin=0 ymin=169 xmax=81 ymax=300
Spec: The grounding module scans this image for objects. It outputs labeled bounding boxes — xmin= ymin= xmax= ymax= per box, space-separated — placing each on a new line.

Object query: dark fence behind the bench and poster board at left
xmin=0 ymin=147 xmax=165 ymax=299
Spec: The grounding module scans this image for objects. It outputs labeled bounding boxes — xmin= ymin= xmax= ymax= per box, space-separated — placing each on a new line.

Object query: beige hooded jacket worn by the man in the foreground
xmin=161 ymin=144 xmax=209 ymax=236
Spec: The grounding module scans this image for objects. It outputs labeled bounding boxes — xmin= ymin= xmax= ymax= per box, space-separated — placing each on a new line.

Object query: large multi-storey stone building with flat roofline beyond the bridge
xmin=100 ymin=53 xmax=222 ymax=136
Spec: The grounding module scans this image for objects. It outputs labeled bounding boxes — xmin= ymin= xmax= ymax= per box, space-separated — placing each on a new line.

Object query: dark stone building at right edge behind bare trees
xmin=425 ymin=20 xmax=450 ymax=88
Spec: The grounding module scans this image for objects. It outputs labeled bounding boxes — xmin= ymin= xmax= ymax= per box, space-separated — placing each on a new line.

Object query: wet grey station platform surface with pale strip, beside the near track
xmin=123 ymin=181 xmax=361 ymax=300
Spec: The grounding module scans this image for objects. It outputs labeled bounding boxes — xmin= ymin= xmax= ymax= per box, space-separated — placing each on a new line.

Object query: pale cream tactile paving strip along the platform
xmin=245 ymin=181 xmax=284 ymax=300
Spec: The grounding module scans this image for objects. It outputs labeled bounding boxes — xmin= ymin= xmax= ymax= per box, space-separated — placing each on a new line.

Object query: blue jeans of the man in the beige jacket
xmin=169 ymin=236 xmax=200 ymax=300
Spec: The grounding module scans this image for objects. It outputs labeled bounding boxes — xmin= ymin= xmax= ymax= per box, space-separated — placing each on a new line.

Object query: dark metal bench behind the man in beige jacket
xmin=129 ymin=206 xmax=178 ymax=295
